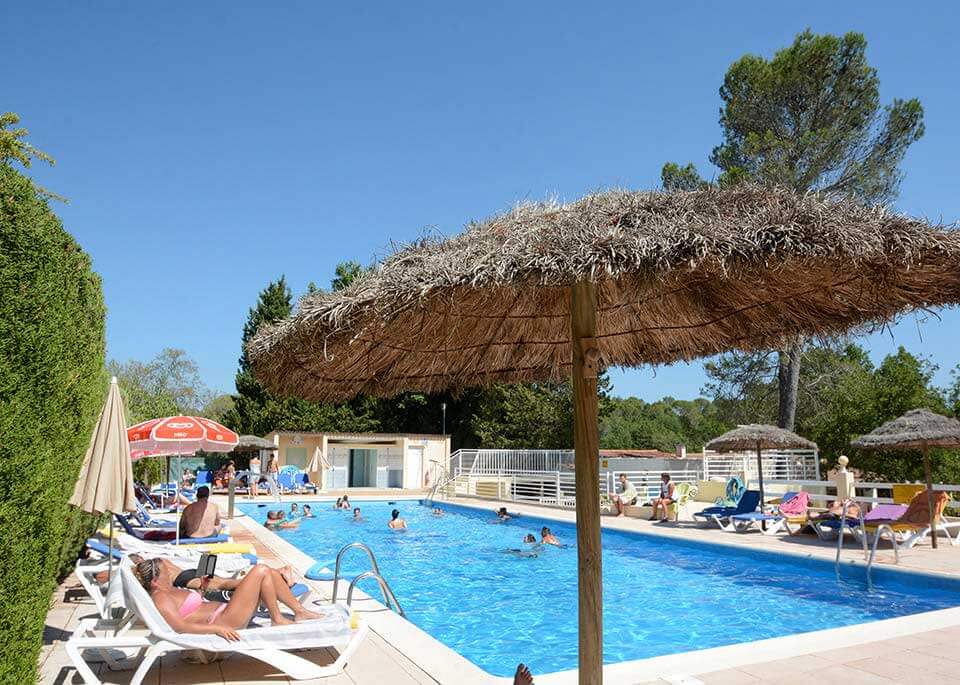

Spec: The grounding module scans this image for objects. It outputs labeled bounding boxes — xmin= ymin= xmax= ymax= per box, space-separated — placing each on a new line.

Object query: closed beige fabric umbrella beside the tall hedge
xmin=70 ymin=376 xmax=137 ymax=588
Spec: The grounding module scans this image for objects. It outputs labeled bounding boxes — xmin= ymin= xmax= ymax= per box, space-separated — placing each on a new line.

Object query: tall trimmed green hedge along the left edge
xmin=0 ymin=163 xmax=107 ymax=683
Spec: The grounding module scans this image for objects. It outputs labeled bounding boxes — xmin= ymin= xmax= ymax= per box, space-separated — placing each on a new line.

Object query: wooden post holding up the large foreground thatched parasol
xmin=570 ymin=282 xmax=603 ymax=685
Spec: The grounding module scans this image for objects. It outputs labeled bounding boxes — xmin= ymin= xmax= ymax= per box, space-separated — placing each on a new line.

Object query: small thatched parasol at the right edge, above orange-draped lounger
xmin=850 ymin=409 xmax=960 ymax=549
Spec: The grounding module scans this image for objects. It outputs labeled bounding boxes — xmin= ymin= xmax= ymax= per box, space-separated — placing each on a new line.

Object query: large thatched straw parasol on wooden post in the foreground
xmin=247 ymin=187 xmax=960 ymax=683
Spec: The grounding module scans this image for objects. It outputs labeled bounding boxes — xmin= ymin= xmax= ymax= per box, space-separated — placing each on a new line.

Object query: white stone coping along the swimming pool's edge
xmin=227 ymin=495 xmax=960 ymax=685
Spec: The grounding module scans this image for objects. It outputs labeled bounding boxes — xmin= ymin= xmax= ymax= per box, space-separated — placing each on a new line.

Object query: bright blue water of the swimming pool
xmin=241 ymin=500 xmax=960 ymax=676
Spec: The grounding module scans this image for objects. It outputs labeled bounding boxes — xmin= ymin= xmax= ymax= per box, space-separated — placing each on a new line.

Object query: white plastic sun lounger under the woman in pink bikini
xmin=66 ymin=557 xmax=367 ymax=685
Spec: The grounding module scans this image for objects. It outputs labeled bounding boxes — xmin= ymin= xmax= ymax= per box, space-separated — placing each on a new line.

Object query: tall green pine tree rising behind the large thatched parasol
xmin=661 ymin=30 xmax=924 ymax=428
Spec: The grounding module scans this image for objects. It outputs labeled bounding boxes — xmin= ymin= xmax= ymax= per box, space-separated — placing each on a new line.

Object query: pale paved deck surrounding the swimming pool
xmin=40 ymin=494 xmax=960 ymax=685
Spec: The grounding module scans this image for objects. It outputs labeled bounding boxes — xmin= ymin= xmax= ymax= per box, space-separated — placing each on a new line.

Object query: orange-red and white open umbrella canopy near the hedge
xmin=127 ymin=416 xmax=240 ymax=458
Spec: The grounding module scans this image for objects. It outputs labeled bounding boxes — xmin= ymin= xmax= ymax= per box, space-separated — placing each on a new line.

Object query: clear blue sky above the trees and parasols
xmin=9 ymin=0 xmax=960 ymax=400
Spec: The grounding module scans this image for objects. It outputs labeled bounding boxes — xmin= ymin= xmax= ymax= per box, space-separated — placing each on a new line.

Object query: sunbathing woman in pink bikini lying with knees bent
xmin=133 ymin=559 xmax=319 ymax=640
